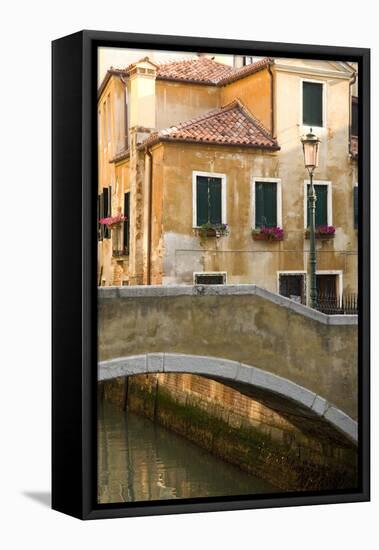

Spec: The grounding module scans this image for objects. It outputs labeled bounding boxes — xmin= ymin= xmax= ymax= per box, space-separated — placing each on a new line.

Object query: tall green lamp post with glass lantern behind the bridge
xmin=301 ymin=128 xmax=320 ymax=308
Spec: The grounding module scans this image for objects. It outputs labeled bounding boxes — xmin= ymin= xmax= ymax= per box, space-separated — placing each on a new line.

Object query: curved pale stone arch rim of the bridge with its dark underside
xmin=98 ymin=353 xmax=358 ymax=445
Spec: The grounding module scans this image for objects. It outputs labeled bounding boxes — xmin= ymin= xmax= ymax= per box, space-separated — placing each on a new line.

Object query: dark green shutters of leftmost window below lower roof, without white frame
xmin=196 ymin=176 xmax=222 ymax=227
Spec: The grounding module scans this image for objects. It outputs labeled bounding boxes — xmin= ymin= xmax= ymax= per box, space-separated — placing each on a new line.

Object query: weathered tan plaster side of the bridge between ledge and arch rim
xmin=98 ymin=287 xmax=358 ymax=419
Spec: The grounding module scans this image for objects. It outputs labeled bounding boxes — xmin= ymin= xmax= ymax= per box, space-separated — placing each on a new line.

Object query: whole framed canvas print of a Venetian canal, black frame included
xmin=52 ymin=31 xmax=370 ymax=519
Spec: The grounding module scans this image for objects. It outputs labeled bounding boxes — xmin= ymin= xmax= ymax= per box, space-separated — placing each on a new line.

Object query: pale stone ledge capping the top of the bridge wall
xmin=98 ymin=285 xmax=358 ymax=325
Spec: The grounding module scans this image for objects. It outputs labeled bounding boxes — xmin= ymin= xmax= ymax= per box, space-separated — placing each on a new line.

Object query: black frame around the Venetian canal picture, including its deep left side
xmin=52 ymin=30 xmax=370 ymax=519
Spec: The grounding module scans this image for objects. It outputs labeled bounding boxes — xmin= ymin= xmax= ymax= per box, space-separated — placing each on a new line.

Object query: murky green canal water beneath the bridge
xmin=98 ymin=402 xmax=277 ymax=503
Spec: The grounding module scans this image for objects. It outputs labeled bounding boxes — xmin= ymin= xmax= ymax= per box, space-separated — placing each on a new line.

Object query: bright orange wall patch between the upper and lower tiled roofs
xmin=221 ymin=69 xmax=272 ymax=131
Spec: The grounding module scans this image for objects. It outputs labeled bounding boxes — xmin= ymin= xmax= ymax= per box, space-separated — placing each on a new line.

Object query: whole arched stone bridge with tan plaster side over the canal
xmin=98 ymin=285 xmax=358 ymax=443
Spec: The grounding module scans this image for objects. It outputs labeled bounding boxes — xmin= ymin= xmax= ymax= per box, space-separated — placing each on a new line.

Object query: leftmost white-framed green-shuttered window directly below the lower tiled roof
xmin=192 ymin=172 xmax=226 ymax=227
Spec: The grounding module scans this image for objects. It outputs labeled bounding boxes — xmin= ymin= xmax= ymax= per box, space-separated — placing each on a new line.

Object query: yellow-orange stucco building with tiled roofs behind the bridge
xmin=98 ymin=56 xmax=358 ymax=303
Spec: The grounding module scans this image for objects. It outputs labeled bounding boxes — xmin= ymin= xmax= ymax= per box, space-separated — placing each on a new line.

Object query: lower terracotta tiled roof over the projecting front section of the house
xmin=140 ymin=99 xmax=279 ymax=150
